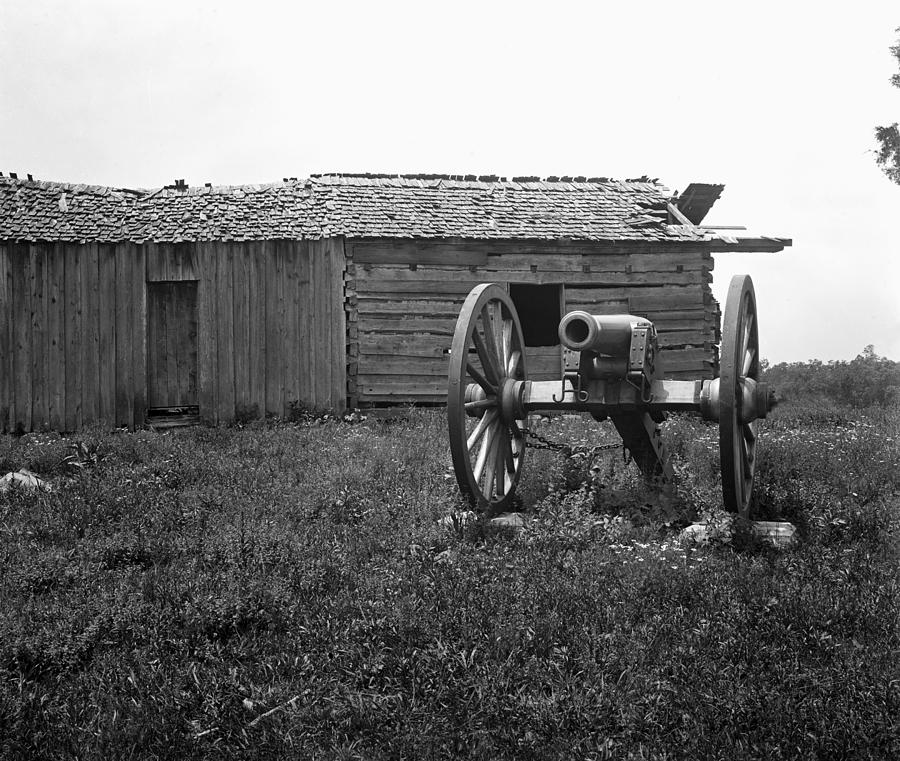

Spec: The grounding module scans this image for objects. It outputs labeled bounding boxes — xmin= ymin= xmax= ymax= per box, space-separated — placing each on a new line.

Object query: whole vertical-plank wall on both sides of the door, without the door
xmin=0 ymin=240 xmax=346 ymax=432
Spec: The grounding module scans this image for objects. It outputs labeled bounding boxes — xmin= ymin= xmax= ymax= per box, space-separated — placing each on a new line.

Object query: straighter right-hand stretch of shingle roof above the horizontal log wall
xmin=310 ymin=175 xmax=680 ymax=241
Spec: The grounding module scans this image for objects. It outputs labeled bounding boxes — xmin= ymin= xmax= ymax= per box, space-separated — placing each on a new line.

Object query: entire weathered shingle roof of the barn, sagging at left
xmin=0 ymin=175 xmax=706 ymax=243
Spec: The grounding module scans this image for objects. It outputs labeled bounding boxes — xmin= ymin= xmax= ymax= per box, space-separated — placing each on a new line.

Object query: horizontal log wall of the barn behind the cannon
xmin=346 ymin=240 xmax=718 ymax=403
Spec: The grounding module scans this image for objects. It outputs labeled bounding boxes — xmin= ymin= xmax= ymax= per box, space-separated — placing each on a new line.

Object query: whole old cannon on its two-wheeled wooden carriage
xmin=447 ymin=275 xmax=775 ymax=517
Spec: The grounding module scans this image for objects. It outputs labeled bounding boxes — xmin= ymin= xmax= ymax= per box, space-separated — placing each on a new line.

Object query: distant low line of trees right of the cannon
xmin=763 ymin=344 xmax=900 ymax=408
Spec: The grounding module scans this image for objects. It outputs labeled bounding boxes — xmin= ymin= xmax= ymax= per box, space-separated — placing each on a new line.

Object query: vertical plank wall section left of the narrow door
xmin=0 ymin=243 xmax=146 ymax=431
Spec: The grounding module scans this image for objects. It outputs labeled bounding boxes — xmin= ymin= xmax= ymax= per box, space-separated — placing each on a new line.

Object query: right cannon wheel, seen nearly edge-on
xmin=719 ymin=275 xmax=759 ymax=518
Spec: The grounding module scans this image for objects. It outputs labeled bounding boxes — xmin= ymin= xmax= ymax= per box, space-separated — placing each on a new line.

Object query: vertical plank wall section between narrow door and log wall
xmin=195 ymin=239 xmax=347 ymax=423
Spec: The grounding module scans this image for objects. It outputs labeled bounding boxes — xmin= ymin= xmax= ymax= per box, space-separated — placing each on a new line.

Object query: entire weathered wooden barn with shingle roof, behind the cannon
xmin=0 ymin=175 xmax=790 ymax=431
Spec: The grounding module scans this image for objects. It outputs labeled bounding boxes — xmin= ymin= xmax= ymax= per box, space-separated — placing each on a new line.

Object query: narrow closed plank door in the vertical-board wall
xmin=147 ymin=280 xmax=199 ymax=418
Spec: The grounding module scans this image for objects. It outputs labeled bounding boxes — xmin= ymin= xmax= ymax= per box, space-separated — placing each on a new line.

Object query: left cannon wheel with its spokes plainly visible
xmin=447 ymin=283 xmax=527 ymax=513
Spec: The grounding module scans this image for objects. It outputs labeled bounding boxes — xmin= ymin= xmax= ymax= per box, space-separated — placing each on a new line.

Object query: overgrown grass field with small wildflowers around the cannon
xmin=0 ymin=400 xmax=900 ymax=759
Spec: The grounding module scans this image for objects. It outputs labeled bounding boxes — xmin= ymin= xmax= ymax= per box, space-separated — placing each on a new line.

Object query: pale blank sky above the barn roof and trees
xmin=0 ymin=0 xmax=900 ymax=362
